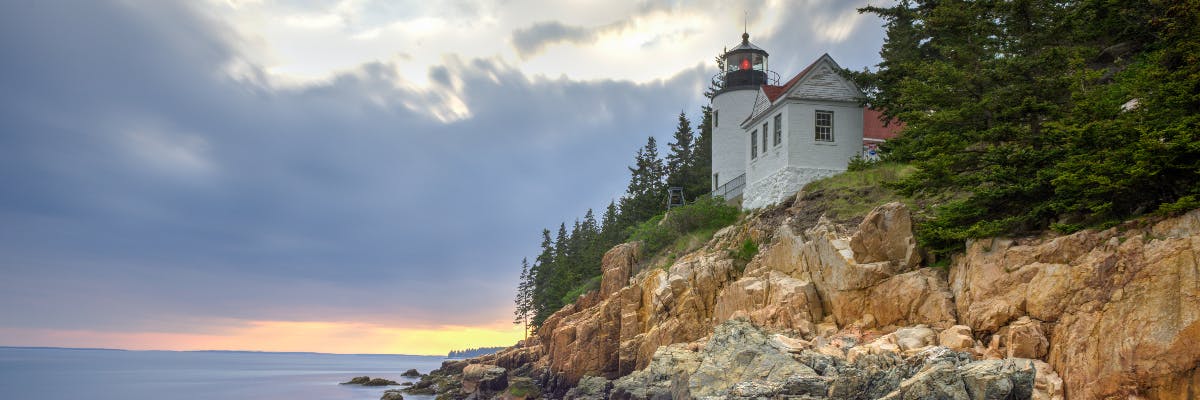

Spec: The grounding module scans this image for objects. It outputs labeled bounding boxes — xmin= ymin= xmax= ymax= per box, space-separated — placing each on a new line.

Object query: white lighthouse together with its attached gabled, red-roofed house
xmin=712 ymin=34 xmax=899 ymax=209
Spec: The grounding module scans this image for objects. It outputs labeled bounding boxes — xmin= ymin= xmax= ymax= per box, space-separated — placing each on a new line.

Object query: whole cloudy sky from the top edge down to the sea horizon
xmin=0 ymin=0 xmax=883 ymax=354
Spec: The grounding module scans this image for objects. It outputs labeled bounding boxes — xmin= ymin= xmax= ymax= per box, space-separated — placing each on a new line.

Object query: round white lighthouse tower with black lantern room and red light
xmin=712 ymin=32 xmax=779 ymax=199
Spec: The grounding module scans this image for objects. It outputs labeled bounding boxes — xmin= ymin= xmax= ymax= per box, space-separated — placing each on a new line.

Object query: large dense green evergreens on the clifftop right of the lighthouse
xmin=850 ymin=0 xmax=1200 ymax=255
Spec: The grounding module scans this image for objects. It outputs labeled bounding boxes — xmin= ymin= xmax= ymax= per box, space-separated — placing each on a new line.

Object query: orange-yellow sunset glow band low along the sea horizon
xmin=0 ymin=321 xmax=524 ymax=356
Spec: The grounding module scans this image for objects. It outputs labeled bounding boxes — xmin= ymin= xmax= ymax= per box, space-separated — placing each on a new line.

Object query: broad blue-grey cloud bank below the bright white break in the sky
xmin=0 ymin=1 xmax=707 ymax=330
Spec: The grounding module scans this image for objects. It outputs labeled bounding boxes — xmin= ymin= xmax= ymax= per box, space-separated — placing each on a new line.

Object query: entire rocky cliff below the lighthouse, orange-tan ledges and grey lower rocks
xmin=417 ymin=196 xmax=1200 ymax=399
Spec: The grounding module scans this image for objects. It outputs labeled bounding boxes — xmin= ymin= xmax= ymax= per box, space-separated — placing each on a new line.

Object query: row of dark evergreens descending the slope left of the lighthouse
xmin=514 ymin=107 xmax=713 ymax=329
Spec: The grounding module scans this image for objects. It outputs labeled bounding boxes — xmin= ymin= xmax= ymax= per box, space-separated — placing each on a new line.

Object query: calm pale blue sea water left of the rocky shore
xmin=0 ymin=347 xmax=443 ymax=400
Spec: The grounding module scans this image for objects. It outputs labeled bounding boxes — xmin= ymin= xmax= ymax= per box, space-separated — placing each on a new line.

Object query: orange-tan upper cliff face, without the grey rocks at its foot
xmin=475 ymin=203 xmax=1200 ymax=399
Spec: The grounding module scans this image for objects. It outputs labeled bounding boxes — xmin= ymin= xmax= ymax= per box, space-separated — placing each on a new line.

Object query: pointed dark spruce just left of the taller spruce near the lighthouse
xmin=620 ymin=136 xmax=666 ymax=226
